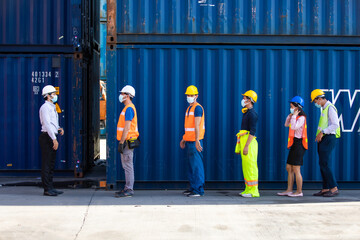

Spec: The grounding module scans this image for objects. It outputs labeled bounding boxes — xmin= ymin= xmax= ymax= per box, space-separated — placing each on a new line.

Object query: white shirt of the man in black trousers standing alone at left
xmin=39 ymin=101 xmax=60 ymax=140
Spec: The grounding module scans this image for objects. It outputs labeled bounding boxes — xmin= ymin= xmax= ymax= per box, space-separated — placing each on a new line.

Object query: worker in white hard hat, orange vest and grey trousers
xmin=115 ymin=85 xmax=139 ymax=197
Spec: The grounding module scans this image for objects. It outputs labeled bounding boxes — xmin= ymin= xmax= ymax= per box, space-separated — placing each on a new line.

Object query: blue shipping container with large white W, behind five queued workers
xmin=107 ymin=44 xmax=360 ymax=184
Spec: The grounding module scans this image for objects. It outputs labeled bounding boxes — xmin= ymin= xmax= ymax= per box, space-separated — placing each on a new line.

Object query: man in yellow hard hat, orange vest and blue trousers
xmin=180 ymin=85 xmax=205 ymax=197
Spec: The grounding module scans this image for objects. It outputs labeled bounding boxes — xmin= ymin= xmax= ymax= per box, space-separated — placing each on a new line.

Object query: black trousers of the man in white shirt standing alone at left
xmin=39 ymin=132 xmax=56 ymax=191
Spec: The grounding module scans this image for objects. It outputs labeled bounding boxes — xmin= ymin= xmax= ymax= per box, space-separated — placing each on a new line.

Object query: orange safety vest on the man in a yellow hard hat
xmin=183 ymin=103 xmax=205 ymax=142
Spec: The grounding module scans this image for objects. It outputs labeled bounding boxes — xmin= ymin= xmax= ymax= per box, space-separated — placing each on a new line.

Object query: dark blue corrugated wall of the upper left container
xmin=0 ymin=0 xmax=81 ymax=45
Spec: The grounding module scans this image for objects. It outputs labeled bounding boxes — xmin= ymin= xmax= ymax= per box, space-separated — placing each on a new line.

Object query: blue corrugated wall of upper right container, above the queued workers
xmin=116 ymin=0 xmax=360 ymax=35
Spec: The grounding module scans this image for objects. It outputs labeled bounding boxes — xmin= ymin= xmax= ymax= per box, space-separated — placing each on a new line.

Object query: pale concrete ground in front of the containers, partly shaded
xmin=0 ymin=187 xmax=360 ymax=240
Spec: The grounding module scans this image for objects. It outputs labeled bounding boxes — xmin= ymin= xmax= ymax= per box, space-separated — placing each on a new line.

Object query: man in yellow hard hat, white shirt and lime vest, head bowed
xmin=311 ymin=89 xmax=340 ymax=197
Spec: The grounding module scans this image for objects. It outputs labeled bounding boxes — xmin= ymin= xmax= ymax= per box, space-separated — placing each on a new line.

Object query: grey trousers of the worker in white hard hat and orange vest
xmin=121 ymin=144 xmax=135 ymax=191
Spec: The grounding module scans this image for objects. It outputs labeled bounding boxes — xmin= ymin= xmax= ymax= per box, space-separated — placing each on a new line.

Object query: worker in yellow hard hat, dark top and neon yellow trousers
xmin=235 ymin=90 xmax=260 ymax=197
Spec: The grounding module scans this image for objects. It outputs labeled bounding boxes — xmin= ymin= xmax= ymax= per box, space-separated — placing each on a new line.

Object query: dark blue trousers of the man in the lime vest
xmin=318 ymin=134 xmax=337 ymax=189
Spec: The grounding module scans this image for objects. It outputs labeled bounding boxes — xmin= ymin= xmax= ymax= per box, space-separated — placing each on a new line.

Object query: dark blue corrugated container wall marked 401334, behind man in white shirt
xmin=0 ymin=54 xmax=85 ymax=171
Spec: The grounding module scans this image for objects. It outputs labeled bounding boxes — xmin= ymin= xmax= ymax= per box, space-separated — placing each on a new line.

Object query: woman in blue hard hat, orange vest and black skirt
xmin=278 ymin=96 xmax=308 ymax=197
